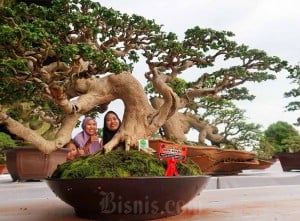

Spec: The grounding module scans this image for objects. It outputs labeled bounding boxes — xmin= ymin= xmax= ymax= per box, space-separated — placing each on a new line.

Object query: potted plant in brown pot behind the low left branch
xmin=0 ymin=102 xmax=68 ymax=181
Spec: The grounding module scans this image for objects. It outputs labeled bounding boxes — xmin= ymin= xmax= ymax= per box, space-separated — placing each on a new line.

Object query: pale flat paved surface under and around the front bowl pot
xmin=0 ymin=161 xmax=300 ymax=221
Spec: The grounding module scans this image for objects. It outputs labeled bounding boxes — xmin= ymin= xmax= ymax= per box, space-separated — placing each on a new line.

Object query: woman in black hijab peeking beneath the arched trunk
xmin=102 ymin=111 xmax=121 ymax=146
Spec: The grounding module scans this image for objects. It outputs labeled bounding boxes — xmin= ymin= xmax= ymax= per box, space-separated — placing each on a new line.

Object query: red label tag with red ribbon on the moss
xmin=158 ymin=144 xmax=187 ymax=176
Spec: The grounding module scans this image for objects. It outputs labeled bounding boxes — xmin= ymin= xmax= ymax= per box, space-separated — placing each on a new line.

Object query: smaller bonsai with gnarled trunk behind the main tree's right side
xmin=145 ymin=81 xmax=262 ymax=149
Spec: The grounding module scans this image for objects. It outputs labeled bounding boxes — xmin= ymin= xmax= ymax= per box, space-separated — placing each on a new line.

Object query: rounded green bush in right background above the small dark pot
xmin=264 ymin=121 xmax=299 ymax=153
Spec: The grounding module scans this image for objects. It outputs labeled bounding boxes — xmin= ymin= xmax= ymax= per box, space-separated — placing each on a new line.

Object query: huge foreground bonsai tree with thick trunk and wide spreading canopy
xmin=0 ymin=0 xmax=288 ymax=153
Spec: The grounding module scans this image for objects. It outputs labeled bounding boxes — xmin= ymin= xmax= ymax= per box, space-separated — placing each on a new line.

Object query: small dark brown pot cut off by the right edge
xmin=276 ymin=152 xmax=300 ymax=171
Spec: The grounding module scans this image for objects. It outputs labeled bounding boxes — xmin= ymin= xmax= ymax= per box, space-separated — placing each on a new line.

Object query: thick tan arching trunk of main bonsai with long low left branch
xmin=0 ymin=72 xmax=177 ymax=153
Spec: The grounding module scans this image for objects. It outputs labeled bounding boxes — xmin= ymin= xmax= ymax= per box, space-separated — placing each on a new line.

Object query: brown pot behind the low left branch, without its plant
xmin=6 ymin=147 xmax=69 ymax=181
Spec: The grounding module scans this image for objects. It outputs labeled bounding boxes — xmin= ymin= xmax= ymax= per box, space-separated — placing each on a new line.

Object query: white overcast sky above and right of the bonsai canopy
xmin=72 ymin=0 xmax=300 ymax=137
